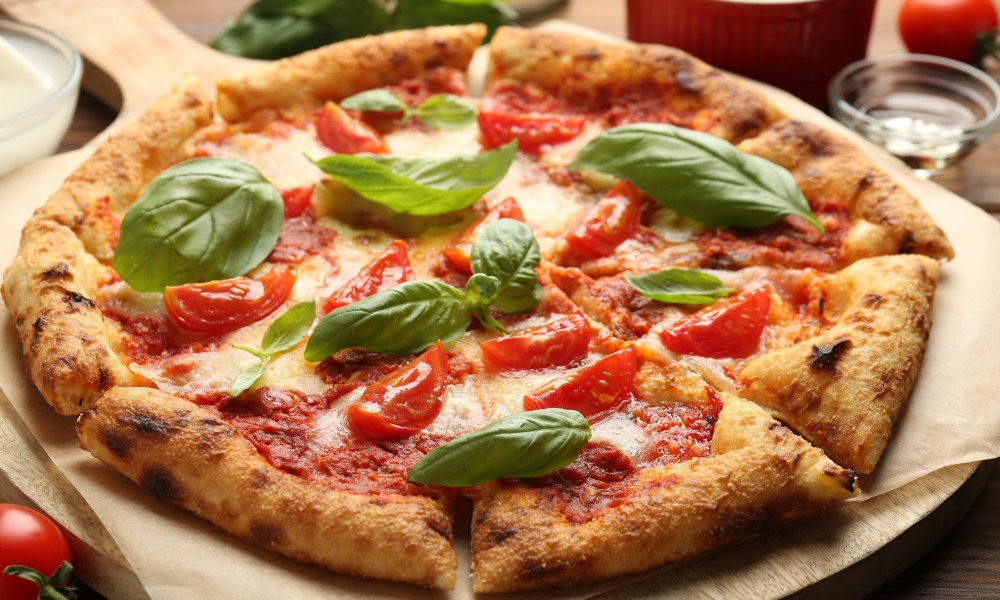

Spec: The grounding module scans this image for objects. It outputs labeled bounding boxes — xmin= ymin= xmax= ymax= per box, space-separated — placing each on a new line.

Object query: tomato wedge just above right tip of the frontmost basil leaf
xmin=524 ymin=346 xmax=637 ymax=419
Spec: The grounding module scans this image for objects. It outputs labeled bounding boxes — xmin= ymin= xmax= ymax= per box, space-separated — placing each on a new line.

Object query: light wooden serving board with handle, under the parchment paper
xmin=0 ymin=0 xmax=992 ymax=599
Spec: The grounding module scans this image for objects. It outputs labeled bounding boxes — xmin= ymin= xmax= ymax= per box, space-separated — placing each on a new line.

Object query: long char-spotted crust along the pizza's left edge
xmin=3 ymin=80 xmax=212 ymax=415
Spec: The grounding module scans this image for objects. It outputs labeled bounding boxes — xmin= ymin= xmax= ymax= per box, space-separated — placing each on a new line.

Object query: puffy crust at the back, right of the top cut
xmin=488 ymin=27 xmax=783 ymax=142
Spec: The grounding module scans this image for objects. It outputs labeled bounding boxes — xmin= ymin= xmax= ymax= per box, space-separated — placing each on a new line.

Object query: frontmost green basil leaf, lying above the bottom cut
xmin=407 ymin=408 xmax=590 ymax=487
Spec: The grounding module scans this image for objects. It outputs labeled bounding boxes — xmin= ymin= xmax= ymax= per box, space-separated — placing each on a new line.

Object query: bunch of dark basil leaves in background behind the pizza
xmin=212 ymin=0 xmax=517 ymax=59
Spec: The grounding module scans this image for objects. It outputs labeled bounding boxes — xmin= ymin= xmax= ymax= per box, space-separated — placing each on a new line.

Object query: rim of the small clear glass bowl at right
xmin=827 ymin=53 xmax=1000 ymax=137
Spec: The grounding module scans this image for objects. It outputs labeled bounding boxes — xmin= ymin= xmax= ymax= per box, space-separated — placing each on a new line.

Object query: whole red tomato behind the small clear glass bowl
xmin=899 ymin=0 xmax=997 ymax=63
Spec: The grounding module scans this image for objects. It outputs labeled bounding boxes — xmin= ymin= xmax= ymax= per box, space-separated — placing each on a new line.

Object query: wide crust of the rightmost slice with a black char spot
xmin=740 ymin=255 xmax=939 ymax=473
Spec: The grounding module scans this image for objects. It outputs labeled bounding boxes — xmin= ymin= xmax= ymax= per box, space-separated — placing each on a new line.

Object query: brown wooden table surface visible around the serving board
xmin=59 ymin=0 xmax=1000 ymax=598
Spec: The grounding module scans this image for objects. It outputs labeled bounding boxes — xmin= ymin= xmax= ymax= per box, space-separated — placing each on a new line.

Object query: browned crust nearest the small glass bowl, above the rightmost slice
xmin=739 ymin=120 xmax=955 ymax=264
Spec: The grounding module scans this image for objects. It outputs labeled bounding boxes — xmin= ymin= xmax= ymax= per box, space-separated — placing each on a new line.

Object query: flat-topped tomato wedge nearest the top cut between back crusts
xmin=476 ymin=112 xmax=587 ymax=154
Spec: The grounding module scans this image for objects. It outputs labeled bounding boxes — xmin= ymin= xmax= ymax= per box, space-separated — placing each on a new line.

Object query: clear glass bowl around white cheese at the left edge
xmin=0 ymin=18 xmax=83 ymax=176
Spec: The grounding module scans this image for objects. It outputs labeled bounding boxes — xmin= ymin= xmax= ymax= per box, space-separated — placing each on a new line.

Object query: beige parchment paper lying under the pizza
xmin=0 ymin=19 xmax=1000 ymax=600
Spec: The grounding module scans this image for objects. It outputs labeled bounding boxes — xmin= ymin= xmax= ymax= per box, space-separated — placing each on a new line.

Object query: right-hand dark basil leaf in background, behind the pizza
xmin=392 ymin=0 xmax=517 ymax=42
